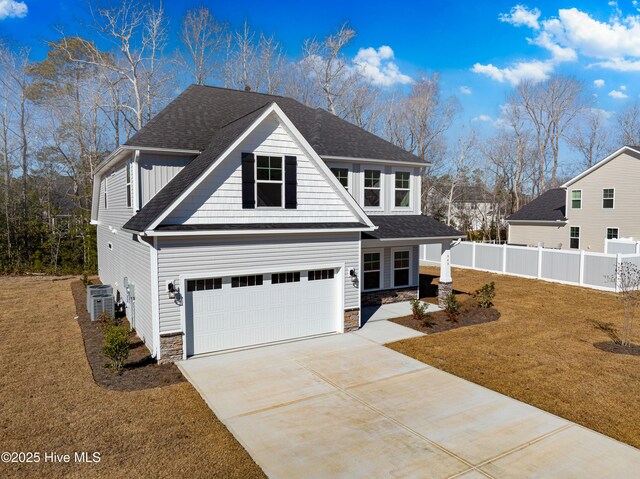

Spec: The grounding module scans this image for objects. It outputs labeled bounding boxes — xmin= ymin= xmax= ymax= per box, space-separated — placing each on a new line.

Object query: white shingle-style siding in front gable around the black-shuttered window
xmin=164 ymin=118 xmax=358 ymax=229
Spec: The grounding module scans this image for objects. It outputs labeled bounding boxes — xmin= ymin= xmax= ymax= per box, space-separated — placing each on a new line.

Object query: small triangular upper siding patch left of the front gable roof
xmin=138 ymin=153 xmax=193 ymax=207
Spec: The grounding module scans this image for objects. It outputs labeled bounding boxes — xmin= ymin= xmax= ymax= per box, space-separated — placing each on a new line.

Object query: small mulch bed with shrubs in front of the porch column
xmin=390 ymin=296 xmax=500 ymax=334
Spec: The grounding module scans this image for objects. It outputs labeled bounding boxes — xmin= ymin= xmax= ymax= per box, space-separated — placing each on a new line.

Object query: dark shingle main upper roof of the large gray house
xmin=124 ymin=85 xmax=424 ymax=231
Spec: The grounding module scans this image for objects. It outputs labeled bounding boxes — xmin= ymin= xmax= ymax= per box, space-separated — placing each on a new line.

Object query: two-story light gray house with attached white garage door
xmin=92 ymin=85 xmax=462 ymax=360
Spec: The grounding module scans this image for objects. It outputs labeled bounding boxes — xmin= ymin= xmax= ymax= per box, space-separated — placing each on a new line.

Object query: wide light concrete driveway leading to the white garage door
xmin=179 ymin=321 xmax=640 ymax=479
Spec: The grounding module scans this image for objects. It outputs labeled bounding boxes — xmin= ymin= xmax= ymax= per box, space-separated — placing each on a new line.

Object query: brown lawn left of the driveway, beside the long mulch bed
xmin=0 ymin=277 xmax=264 ymax=478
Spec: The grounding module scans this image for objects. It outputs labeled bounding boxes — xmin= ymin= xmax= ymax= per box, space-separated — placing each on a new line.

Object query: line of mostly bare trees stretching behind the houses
xmin=0 ymin=0 xmax=640 ymax=273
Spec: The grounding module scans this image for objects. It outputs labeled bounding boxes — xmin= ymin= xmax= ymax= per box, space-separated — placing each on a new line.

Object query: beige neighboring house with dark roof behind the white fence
xmin=507 ymin=146 xmax=640 ymax=252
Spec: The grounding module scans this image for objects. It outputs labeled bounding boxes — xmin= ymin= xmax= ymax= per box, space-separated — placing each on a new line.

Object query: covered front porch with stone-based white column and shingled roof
xmin=360 ymin=215 xmax=464 ymax=308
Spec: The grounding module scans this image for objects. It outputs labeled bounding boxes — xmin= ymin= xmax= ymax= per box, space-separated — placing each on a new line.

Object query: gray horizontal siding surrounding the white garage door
xmin=158 ymin=233 xmax=360 ymax=333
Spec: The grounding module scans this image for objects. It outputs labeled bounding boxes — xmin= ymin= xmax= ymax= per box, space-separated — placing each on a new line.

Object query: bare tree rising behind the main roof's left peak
xmin=178 ymin=6 xmax=227 ymax=85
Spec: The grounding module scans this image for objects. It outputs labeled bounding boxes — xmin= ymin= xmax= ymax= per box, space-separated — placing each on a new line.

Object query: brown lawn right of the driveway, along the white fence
xmin=390 ymin=268 xmax=640 ymax=447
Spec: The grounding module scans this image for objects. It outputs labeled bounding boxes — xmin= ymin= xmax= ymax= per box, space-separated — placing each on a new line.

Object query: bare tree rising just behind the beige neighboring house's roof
xmin=567 ymin=109 xmax=611 ymax=169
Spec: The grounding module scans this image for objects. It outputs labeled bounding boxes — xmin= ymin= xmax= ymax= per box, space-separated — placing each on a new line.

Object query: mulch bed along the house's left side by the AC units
xmin=71 ymin=281 xmax=185 ymax=391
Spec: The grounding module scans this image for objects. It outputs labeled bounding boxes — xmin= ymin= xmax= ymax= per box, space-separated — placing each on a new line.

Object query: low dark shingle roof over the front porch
xmin=362 ymin=215 xmax=465 ymax=239
